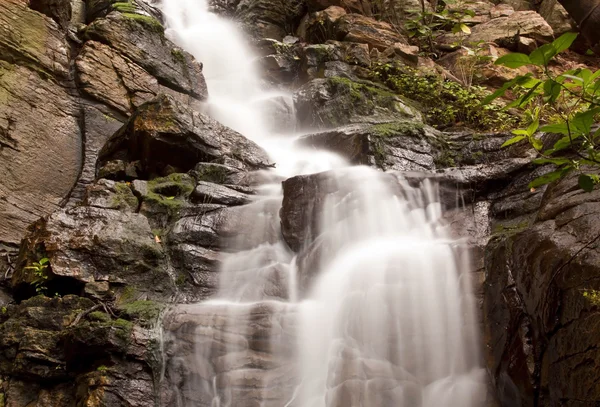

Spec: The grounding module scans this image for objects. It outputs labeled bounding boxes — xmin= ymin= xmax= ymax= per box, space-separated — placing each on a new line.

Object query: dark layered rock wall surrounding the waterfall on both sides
xmin=0 ymin=0 xmax=600 ymax=407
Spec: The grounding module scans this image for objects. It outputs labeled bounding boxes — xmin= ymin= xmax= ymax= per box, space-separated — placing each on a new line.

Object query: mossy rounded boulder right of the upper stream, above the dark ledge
xmin=294 ymin=77 xmax=420 ymax=129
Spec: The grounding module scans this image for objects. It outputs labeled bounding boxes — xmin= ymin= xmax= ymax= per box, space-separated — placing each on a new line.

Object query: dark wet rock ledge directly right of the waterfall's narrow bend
xmin=299 ymin=121 xmax=439 ymax=171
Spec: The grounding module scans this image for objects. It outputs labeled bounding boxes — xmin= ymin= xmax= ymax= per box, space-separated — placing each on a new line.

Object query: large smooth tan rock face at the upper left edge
xmin=0 ymin=0 xmax=82 ymax=249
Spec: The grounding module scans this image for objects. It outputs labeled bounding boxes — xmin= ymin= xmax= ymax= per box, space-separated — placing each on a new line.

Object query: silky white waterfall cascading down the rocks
xmin=163 ymin=0 xmax=485 ymax=407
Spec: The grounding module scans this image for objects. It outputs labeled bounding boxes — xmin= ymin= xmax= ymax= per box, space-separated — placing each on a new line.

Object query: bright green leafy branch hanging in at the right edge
xmin=484 ymin=33 xmax=600 ymax=192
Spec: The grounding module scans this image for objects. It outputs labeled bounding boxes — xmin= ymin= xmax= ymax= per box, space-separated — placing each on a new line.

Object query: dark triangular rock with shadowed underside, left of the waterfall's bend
xmin=98 ymin=95 xmax=268 ymax=177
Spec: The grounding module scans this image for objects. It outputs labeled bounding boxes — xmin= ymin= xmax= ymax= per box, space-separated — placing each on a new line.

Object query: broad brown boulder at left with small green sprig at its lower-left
xmin=12 ymin=206 xmax=173 ymax=299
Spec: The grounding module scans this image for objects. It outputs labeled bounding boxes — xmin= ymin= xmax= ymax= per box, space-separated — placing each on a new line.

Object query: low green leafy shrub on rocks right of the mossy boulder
xmin=374 ymin=64 xmax=516 ymax=130
